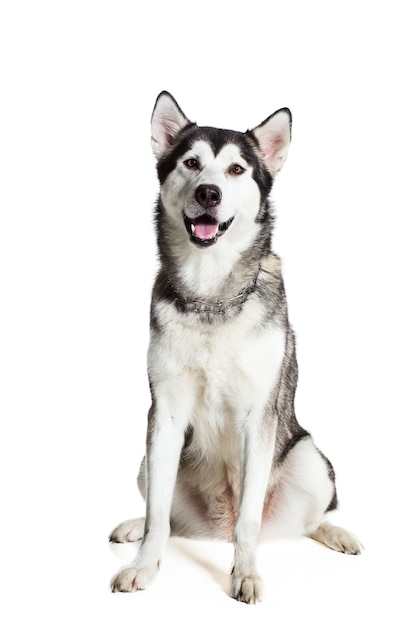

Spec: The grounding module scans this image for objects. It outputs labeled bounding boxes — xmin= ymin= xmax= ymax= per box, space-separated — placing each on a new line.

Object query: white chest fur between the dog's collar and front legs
xmin=148 ymin=300 xmax=285 ymax=448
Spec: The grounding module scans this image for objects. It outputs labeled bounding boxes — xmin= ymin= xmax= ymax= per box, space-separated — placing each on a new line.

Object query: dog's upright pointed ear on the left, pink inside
xmin=151 ymin=91 xmax=191 ymax=159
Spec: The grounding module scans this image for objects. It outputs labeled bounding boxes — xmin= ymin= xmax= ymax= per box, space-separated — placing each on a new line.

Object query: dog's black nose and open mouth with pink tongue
xmin=184 ymin=185 xmax=234 ymax=247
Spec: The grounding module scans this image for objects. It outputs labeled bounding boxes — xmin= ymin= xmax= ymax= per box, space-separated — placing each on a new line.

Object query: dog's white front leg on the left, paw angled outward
xmin=112 ymin=402 xmax=185 ymax=591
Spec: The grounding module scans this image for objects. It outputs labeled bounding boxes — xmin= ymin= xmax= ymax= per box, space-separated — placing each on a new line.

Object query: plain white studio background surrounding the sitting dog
xmin=0 ymin=0 xmax=417 ymax=626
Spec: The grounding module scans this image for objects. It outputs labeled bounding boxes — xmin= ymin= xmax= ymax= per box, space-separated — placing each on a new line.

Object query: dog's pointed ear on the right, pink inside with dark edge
xmin=251 ymin=109 xmax=292 ymax=176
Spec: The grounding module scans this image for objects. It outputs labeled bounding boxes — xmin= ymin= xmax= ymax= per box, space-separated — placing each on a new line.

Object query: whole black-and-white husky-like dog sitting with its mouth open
xmin=110 ymin=91 xmax=362 ymax=603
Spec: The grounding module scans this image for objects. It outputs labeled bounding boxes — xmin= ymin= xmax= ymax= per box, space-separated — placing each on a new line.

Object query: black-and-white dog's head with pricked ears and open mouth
xmin=151 ymin=91 xmax=291 ymax=249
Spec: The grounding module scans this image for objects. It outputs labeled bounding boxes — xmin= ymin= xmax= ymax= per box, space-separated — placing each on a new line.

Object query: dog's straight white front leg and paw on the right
xmin=232 ymin=414 xmax=274 ymax=604
